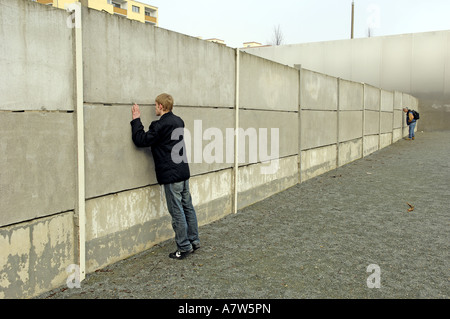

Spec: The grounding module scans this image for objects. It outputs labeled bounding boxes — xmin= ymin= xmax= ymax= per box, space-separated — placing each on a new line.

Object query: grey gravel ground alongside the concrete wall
xmin=37 ymin=132 xmax=450 ymax=299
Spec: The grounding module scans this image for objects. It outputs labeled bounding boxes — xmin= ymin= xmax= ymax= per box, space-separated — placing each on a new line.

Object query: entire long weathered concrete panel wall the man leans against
xmin=0 ymin=0 xmax=415 ymax=298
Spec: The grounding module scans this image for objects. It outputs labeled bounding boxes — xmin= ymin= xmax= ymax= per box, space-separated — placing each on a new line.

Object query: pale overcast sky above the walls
xmin=140 ymin=0 xmax=450 ymax=48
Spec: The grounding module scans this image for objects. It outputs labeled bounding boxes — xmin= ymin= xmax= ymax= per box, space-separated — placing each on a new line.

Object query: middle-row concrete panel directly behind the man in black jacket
xmin=85 ymin=104 xmax=234 ymax=198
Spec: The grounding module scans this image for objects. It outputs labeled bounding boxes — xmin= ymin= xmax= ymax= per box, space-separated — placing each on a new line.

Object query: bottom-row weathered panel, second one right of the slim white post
xmin=301 ymin=145 xmax=337 ymax=181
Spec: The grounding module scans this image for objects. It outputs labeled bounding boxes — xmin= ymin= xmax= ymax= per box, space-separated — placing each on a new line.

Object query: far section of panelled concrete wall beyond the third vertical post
xmin=299 ymin=68 xmax=418 ymax=181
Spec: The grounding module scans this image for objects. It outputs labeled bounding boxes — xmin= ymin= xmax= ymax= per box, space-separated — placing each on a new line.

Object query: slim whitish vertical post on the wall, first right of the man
xmin=232 ymin=48 xmax=240 ymax=214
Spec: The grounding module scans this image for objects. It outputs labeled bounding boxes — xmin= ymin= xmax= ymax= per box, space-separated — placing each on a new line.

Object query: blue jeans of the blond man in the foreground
xmin=164 ymin=180 xmax=200 ymax=252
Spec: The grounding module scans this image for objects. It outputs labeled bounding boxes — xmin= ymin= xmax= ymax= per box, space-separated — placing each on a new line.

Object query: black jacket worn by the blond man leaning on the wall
xmin=131 ymin=112 xmax=190 ymax=184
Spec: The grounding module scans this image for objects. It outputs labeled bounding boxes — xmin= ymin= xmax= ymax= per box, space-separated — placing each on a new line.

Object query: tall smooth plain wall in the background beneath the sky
xmin=244 ymin=30 xmax=450 ymax=131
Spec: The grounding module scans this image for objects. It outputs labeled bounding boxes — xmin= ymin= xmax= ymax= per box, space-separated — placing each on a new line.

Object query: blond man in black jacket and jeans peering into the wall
xmin=131 ymin=93 xmax=200 ymax=259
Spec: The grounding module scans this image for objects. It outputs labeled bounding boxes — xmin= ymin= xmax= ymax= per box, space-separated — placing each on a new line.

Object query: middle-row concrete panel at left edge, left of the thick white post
xmin=0 ymin=112 xmax=77 ymax=226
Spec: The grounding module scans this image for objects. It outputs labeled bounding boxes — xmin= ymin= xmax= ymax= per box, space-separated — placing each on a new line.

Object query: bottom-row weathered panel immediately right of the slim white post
xmin=237 ymin=156 xmax=298 ymax=209
